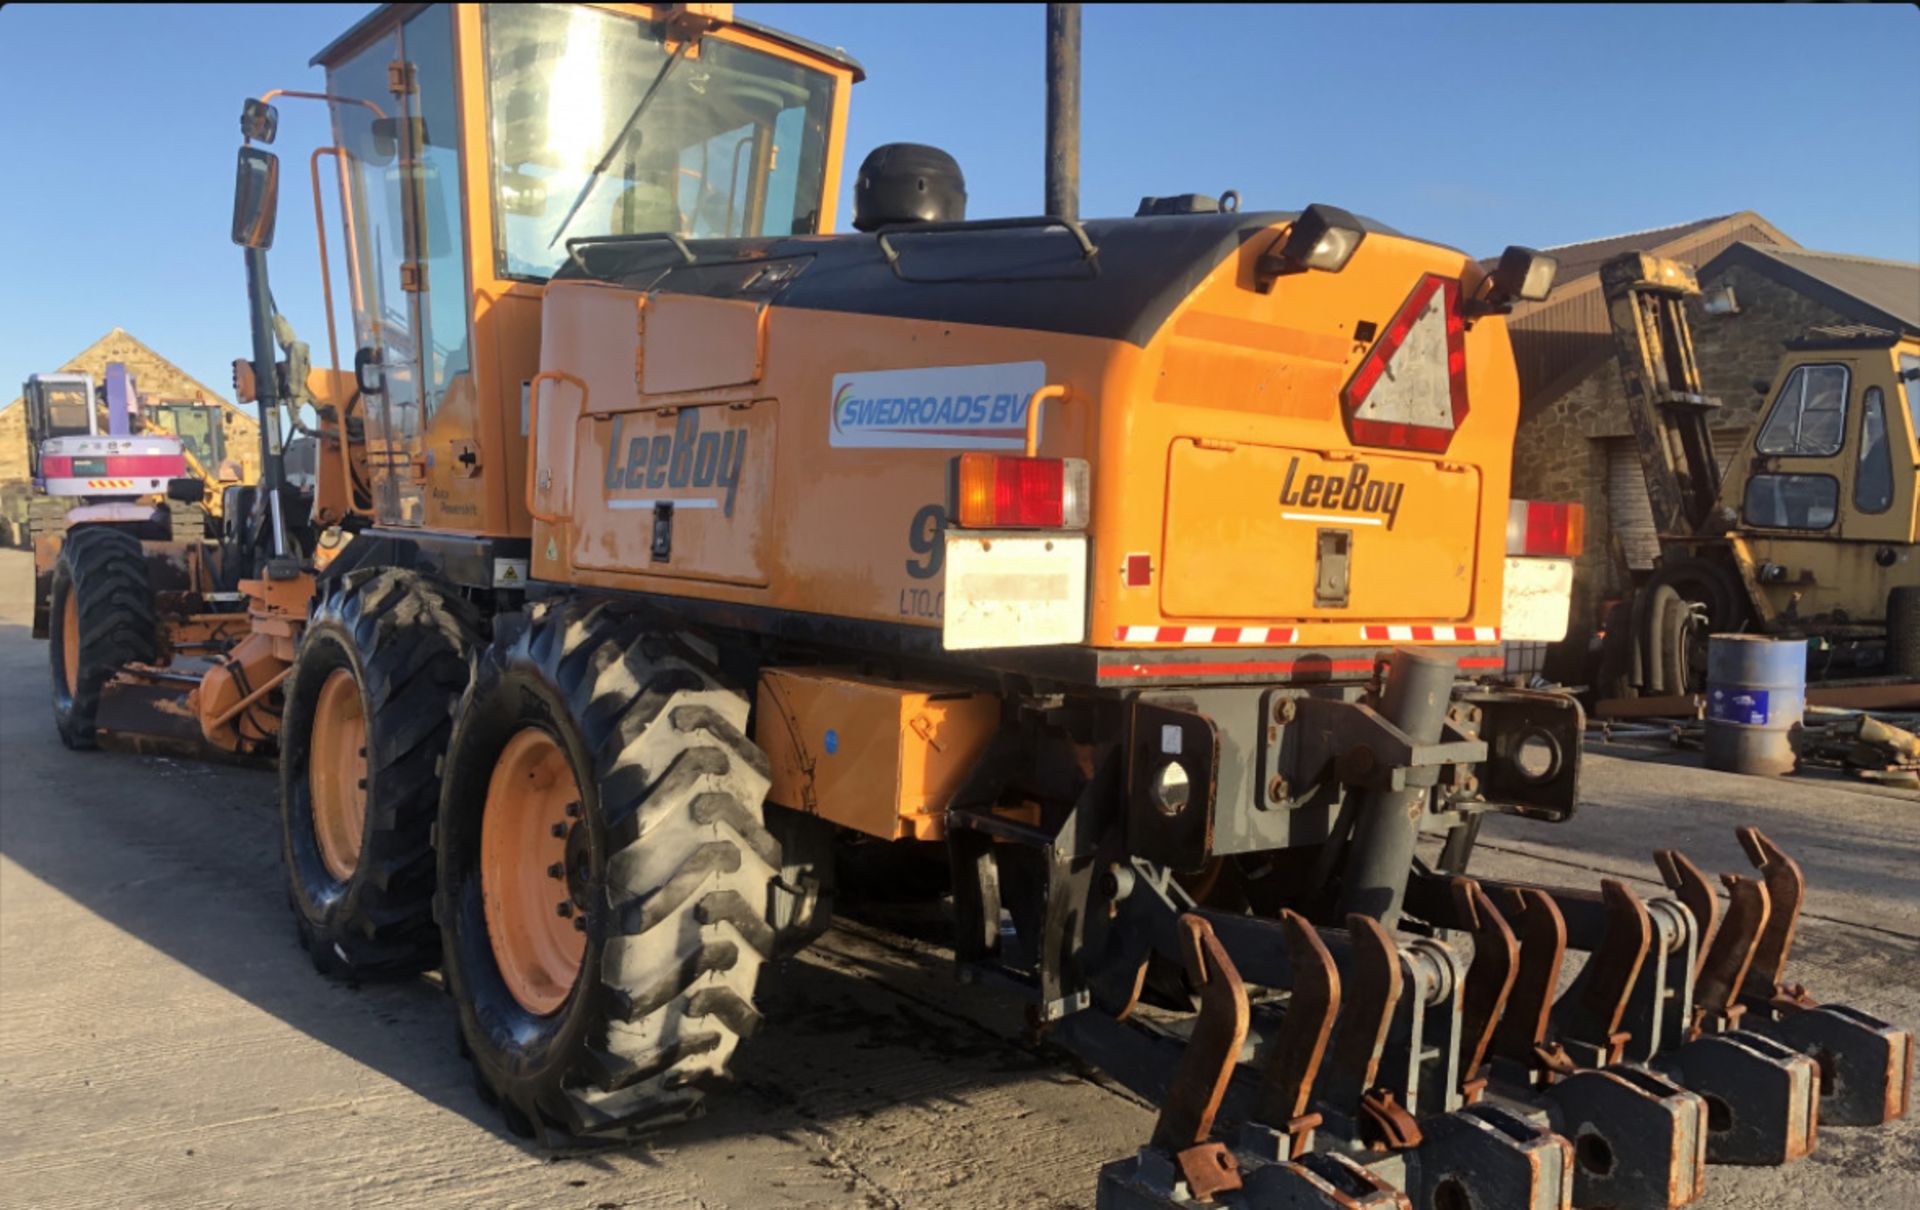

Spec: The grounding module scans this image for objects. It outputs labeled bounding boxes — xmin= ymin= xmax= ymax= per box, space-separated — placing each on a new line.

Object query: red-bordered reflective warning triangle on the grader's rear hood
xmin=1340 ymin=273 xmax=1467 ymax=453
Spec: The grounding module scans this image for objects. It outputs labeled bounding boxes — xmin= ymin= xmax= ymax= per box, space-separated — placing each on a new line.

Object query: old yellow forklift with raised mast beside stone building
xmin=1597 ymin=252 xmax=1920 ymax=705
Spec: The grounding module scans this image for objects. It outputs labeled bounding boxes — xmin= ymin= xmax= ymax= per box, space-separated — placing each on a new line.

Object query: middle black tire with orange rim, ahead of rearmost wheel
xmin=280 ymin=569 xmax=476 ymax=980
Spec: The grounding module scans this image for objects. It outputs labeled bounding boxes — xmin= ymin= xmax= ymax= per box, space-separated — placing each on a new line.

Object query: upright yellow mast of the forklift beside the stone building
xmin=1599 ymin=252 xmax=1720 ymax=540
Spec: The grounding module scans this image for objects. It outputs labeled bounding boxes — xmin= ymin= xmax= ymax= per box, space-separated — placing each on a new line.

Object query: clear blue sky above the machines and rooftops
xmin=0 ymin=4 xmax=1920 ymax=411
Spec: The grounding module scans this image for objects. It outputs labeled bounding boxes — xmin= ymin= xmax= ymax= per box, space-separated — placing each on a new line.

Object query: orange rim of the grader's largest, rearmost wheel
xmin=480 ymin=728 xmax=588 ymax=1016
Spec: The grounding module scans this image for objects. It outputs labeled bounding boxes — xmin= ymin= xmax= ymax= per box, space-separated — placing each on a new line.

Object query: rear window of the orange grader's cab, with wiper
xmin=486 ymin=4 xmax=833 ymax=278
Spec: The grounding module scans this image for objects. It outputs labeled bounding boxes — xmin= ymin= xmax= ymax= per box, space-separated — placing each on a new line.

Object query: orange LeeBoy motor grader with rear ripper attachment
xmin=52 ymin=4 xmax=1908 ymax=1208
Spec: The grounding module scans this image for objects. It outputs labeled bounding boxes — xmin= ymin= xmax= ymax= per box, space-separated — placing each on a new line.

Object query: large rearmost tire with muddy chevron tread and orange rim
xmin=434 ymin=605 xmax=781 ymax=1147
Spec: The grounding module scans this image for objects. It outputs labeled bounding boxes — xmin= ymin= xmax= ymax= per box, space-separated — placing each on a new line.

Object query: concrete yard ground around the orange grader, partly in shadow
xmin=0 ymin=551 xmax=1920 ymax=1210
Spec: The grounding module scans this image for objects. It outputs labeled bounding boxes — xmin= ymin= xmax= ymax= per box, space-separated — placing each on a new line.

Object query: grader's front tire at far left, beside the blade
xmin=46 ymin=528 xmax=159 ymax=749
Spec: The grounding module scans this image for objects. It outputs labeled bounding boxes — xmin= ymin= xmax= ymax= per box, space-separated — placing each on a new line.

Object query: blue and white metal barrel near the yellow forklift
xmin=1707 ymin=634 xmax=1807 ymax=776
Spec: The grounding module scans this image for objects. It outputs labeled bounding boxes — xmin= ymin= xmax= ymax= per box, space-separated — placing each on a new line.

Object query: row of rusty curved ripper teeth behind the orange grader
xmin=1100 ymin=828 xmax=1912 ymax=1210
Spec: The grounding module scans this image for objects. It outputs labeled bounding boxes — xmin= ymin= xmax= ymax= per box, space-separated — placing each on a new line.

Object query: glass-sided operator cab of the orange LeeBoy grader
xmin=236 ymin=4 xmax=860 ymax=538
